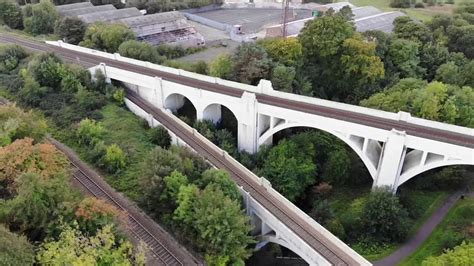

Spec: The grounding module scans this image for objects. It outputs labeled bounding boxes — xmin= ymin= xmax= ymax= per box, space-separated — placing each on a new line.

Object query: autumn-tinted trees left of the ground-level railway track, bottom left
xmin=0 ymin=104 xmax=145 ymax=265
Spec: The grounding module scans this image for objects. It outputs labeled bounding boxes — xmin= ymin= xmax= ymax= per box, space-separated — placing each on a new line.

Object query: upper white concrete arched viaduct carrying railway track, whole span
xmin=38 ymin=41 xmax=474 ymax=191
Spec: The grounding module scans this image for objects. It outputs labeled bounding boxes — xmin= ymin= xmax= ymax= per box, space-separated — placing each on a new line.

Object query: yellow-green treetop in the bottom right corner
xmin=422 ymin=242 xmax=474 ymax=266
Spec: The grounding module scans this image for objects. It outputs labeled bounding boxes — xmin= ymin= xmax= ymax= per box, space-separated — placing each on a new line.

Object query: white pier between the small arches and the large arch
xmin=237 ymin=92 xmax=258 ymax=153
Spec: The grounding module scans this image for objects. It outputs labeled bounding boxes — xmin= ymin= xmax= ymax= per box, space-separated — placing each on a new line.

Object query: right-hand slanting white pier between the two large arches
xmin=373 ymin=129 xmax=406 ymax=192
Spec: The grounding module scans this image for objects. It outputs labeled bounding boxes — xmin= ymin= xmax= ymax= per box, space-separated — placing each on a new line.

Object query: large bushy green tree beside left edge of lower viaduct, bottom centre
xmin=174 ymin=186 xmax=253 ymax=263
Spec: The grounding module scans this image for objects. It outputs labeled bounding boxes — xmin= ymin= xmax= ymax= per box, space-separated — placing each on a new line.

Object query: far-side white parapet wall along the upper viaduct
xmin=46 ymin=41 xmax=473 ymax=135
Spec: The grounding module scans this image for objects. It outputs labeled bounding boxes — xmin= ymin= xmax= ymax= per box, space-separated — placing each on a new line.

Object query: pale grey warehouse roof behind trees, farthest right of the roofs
xmin=354 ymin=11 xmax=406 ymax=33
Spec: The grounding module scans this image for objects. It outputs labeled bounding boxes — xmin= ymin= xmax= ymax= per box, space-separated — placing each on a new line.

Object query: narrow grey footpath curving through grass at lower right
xmin=374 ymin=192 xmax=474 ymax=266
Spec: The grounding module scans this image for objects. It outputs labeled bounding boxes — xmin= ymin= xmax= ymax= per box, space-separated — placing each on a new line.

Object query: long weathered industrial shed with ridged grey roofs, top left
xmin=56 ymin=2 xmax=206 ymax=48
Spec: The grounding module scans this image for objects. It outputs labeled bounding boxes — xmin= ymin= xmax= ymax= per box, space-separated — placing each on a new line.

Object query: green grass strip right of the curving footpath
xmin=400 ymin=198 xmax=474 ymax=265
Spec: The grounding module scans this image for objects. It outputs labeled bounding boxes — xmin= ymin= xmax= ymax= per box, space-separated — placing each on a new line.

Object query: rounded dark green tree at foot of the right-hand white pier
xmin=362 ymin=188 xmax=409 ymax=242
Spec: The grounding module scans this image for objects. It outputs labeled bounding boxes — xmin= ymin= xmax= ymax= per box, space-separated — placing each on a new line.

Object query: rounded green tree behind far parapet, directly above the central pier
xmin=232 ymin=43 xmax=272 ymax=85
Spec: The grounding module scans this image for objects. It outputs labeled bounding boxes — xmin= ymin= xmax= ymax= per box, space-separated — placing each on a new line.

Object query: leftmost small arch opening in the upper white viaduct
xmin=164 ymin=93 xmax=197 ymax=125
